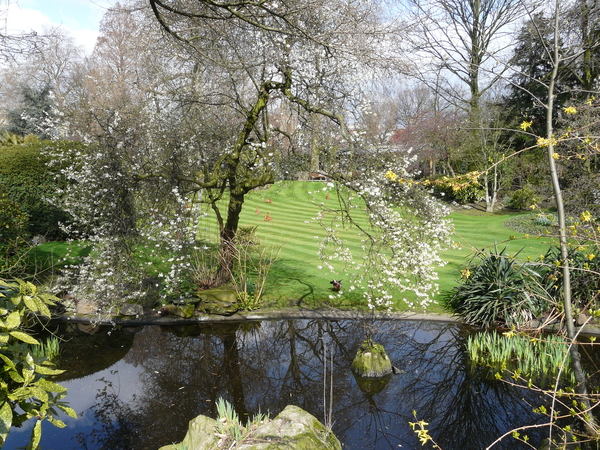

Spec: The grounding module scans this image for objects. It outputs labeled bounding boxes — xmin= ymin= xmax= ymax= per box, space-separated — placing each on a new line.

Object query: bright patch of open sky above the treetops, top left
xmin=0 ymin=0 xmax=117 ymax=54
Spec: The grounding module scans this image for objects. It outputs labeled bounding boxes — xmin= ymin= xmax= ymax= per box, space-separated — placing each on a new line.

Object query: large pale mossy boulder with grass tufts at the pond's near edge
xmin=159 ymin=405 xmax=342 ymax=450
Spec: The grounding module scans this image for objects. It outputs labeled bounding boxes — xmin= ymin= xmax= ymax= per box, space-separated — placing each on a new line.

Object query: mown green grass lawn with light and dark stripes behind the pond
xmin=31 ymin=181 xmax=551 ymax=312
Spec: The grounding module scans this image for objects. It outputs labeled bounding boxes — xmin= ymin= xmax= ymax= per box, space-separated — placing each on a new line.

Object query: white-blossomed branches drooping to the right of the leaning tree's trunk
xmin=319 ymin=158 xmax=452 ymax=310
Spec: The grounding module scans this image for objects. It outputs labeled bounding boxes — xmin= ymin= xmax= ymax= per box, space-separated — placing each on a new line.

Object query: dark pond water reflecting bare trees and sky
xmin=4 ymin=320 xmax=572 ymax=450
